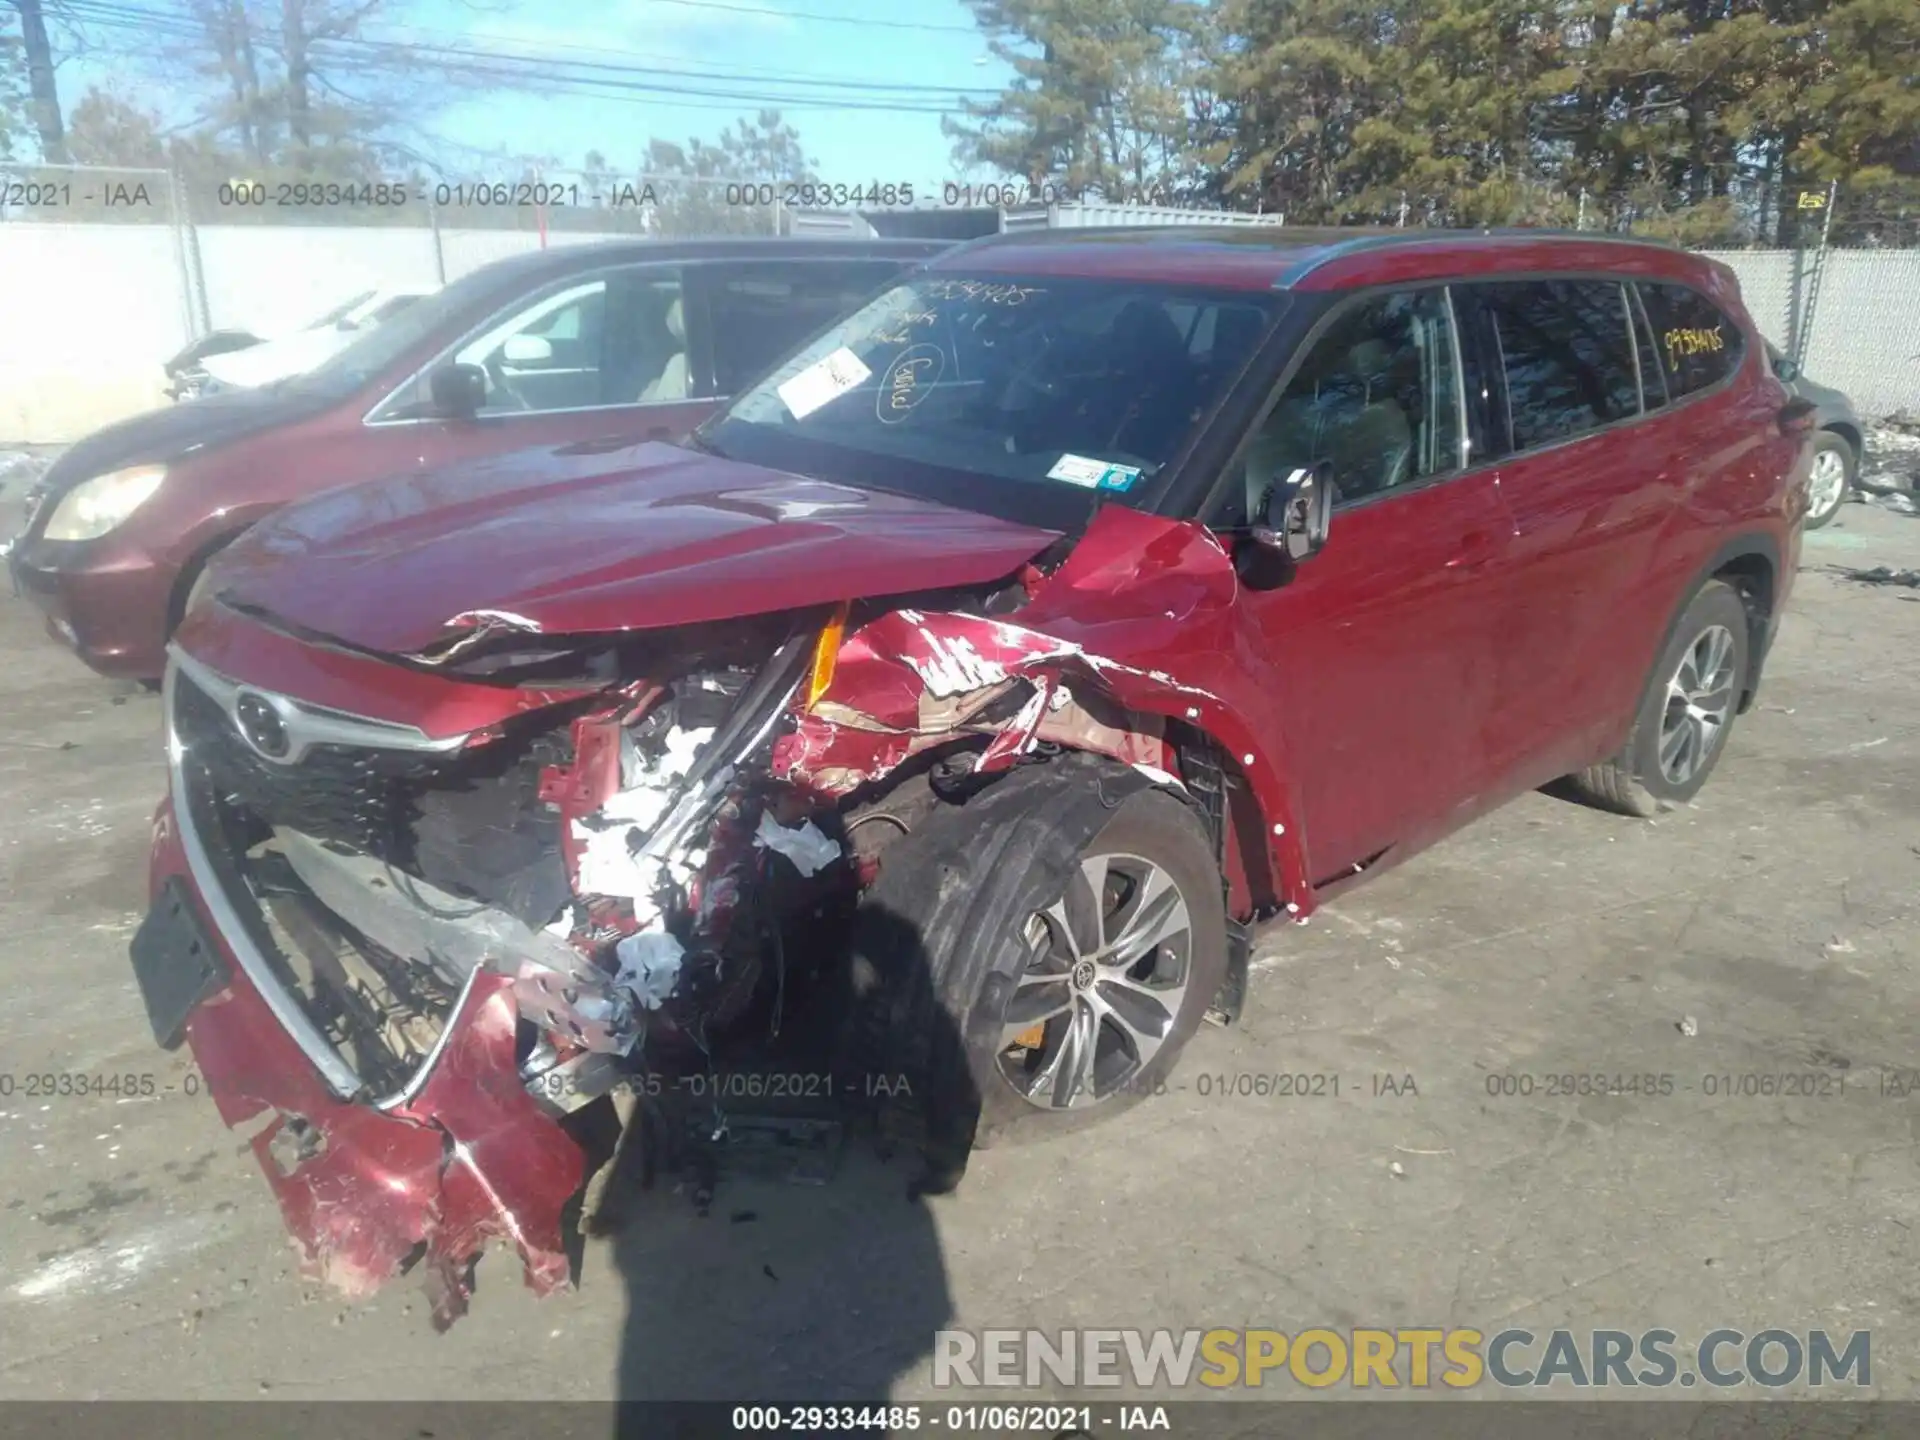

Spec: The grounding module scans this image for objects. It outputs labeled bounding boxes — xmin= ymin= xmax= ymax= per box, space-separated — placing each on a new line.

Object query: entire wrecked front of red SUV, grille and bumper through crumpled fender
xmin=134 ymin=513 xmax=1290 ymax=1325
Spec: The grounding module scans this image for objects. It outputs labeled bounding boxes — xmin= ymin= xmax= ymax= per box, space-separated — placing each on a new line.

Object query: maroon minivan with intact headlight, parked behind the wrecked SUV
xmin=8 ymin=240 xmax=943 ymax=680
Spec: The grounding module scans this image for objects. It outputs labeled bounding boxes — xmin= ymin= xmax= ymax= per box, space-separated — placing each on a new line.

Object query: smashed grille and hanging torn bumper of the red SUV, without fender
xmin=151 ymin=599 xmax=871 ymax=1323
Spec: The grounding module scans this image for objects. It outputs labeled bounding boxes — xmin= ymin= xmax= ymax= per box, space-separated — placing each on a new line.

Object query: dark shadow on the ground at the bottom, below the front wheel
xmin=588 ymin=914 xmax=977 ymax=1436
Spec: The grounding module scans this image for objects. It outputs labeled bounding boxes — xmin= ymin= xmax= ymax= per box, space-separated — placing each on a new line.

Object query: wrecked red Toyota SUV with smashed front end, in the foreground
xmin=132 ymin=230 xmax=1811 ymax=1323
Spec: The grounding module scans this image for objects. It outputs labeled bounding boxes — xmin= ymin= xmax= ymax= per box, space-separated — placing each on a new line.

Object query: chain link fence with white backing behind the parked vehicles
xmin=0 ymin=163 xmax=1920 ymax=440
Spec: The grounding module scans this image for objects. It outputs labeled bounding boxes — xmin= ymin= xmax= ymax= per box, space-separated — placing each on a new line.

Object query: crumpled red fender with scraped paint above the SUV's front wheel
xmin=774 ymin=505 xmax=1313 ymax=914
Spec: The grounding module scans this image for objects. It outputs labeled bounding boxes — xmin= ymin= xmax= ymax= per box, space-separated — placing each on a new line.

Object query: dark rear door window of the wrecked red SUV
xmin=1475 ymin=280 xmax=1640 ymax=451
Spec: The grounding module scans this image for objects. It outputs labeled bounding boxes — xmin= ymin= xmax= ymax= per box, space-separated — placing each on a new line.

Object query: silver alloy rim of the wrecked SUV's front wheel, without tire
xmin=998 ymin=854 xmax=1192 ymax=1110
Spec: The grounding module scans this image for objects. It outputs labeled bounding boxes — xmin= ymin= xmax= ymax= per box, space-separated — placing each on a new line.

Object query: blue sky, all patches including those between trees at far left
xmin=30 ymin=0 xmax=1012 ymax=186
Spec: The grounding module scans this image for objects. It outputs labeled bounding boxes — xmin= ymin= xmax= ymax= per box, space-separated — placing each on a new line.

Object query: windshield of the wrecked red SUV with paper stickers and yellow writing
xmin=699 ymin=273 xmax=1283 ymax=524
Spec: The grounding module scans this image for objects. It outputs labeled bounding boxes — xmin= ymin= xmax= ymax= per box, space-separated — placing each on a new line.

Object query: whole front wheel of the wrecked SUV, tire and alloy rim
xmin=852 ymin=756 xmax=1227 ymax=1188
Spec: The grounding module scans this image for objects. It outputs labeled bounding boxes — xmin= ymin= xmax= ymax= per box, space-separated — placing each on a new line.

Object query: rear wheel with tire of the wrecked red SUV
xmin=1569 ymin=580 xmax=1749 ymax=820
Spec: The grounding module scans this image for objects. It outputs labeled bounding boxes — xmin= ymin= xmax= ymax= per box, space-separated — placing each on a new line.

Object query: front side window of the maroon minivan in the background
xmin=380 ymin=267 xmax=691 ymax=419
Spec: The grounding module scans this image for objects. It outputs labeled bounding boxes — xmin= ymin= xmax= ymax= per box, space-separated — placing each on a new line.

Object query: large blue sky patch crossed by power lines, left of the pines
xmin=341 ymin=0 xmax=1012 ymax=184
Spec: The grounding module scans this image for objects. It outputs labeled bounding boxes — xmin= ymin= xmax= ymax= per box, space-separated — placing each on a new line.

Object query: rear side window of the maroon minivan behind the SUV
xmin=707 ymin=259 xmax=900 ymax=396
